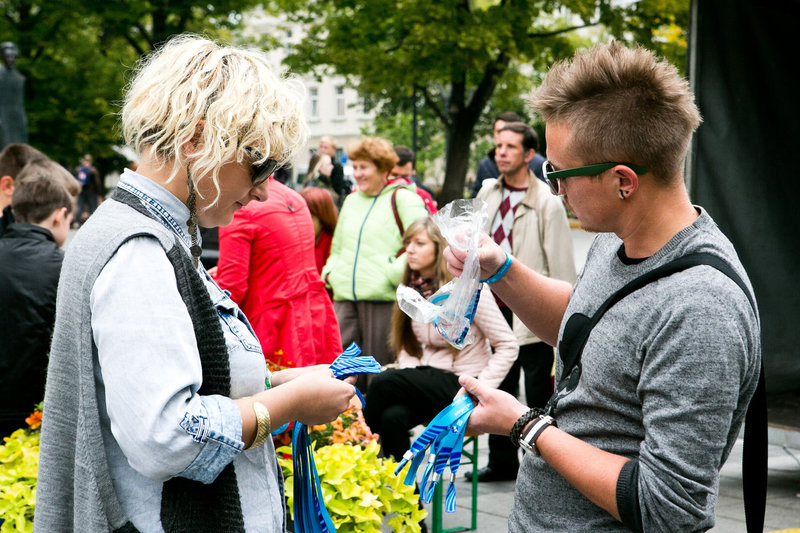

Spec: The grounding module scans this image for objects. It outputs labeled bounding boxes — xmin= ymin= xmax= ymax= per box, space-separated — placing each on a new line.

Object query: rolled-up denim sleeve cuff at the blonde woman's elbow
xmin=178 ymin=396 xmax=244 ymax=484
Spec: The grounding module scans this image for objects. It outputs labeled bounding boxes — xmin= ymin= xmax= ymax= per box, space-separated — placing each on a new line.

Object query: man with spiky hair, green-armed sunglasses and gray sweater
xmin=445 ymin=43 xmax=766 ymax=533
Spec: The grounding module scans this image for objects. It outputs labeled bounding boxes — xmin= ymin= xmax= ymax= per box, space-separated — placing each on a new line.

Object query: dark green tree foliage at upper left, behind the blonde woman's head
xmin=0 ymin=0 xmax=256 ymax=174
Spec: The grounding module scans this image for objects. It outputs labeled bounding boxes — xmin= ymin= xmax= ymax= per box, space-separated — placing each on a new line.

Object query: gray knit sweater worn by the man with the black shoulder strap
xmin=509 ymin=212 xmax=761 ymax=533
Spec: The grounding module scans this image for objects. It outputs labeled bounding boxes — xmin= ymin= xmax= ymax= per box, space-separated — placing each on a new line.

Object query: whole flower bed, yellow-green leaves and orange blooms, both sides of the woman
xmin=0 ymin=406 xmax=427 ymax=533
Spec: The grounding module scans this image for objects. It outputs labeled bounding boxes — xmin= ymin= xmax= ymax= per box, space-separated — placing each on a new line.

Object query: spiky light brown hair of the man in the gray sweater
xmin=529 ymin=42 xmax=702 ymax=183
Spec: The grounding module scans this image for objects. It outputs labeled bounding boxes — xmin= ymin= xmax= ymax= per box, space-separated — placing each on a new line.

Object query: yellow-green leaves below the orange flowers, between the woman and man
xmin=277 ymin=441 xmax=427 ymax=533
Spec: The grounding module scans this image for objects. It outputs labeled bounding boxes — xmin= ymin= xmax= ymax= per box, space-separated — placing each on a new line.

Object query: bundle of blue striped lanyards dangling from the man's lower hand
xmin=394 ymin=394 xmax=475 ymax=513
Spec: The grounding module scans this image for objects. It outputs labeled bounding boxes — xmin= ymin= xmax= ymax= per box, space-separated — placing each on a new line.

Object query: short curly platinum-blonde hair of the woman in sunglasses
xmin=122 ymin=35 xmax=307 ymax=201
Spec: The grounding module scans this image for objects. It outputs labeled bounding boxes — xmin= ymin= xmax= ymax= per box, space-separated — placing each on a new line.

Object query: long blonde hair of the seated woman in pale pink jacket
xmin=389 ymin=216 xmax=453 ymax=358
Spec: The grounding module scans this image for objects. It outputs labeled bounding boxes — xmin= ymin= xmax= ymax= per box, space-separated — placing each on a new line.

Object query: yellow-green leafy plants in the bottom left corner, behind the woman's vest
xmin=0 ymin=429 xmax=40 ymax=533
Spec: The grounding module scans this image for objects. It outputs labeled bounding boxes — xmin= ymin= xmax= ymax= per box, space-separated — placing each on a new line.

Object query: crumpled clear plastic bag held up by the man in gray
xmin=397 ymin=199 xmax=488 ymax=349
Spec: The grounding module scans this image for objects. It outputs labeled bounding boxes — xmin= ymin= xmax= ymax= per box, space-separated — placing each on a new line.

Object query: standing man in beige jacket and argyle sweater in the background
xmin=477 ymin=122 xmax=575 ymax=481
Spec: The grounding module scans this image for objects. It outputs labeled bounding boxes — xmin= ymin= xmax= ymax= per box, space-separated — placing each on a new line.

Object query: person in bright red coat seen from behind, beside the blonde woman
xmin=216 ymin=179 xmax=342 ymax=367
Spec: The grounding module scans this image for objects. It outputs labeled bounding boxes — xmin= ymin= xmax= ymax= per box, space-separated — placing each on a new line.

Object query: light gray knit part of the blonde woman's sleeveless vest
xmin=35 ymin=196 xmax=237 ymax=532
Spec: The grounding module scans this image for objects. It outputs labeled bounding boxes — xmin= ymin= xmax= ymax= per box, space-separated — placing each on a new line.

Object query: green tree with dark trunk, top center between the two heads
xmin=272 ymin=0 xmax=688 ymax=202
